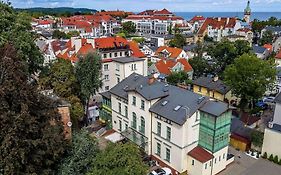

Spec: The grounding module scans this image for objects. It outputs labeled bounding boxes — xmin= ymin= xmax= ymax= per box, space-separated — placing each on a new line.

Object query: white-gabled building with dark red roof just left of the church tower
xmin=197 ymin=17 xmax=242 ymax=41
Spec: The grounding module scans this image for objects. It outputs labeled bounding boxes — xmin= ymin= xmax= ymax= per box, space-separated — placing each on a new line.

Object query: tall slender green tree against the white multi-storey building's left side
xmin=75 ymin=52 xmax=102 ymax=111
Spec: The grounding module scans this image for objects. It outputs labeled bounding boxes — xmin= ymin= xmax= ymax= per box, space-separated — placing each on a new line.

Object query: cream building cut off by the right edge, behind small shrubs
xmin=262 ymin=93 xmax=281 ymax=157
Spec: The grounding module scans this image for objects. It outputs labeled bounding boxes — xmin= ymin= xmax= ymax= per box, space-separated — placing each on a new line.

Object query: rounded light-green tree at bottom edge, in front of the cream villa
xmin=88 ymin=143 xmax=148 ymax=175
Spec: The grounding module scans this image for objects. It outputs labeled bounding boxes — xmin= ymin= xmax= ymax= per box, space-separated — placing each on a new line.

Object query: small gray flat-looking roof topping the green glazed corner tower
xmin=200 ymin=100 xmax=229 ymax=117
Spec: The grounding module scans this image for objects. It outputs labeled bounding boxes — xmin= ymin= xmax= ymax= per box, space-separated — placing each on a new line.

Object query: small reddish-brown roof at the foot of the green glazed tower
xmin=187 ymin=146 xmax=214 ymax=163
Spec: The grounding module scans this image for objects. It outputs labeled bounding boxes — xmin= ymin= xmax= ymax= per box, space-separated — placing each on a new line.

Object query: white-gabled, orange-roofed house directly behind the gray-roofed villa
xmin=148 ymin=58 xmax=193 ymax=79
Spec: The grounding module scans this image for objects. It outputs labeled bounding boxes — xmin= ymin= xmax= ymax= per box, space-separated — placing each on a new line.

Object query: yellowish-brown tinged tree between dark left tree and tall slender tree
xmin=39 ymin=59 xmax=83 ymax=128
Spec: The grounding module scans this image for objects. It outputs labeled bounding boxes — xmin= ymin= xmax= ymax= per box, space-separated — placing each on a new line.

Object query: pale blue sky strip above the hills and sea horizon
xmin=7 ymin=0 xmax=281 ymax=12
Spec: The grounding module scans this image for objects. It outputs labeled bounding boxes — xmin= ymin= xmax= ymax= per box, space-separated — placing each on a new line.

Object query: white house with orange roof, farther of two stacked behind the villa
xmin=151 ymin=46 xmax=188 ymax=63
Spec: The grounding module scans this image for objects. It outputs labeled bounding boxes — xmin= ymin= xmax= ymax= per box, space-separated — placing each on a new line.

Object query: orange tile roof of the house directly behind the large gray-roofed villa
xmin=155 ymin=58 xmax=193 ymax=75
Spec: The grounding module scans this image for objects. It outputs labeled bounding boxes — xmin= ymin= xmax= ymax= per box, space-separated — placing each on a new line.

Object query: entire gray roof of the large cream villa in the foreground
xmin=109 ymin=73 xmax=228 ymax=125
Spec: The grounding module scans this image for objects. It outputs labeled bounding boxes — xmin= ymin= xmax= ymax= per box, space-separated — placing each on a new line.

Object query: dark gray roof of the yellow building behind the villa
xmin=193 ymin=76 xmax=231 ymax=94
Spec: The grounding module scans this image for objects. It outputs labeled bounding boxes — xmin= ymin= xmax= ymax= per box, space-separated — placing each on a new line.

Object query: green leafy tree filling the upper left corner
xmin=0 ymin=1 xmax=44 ymax=74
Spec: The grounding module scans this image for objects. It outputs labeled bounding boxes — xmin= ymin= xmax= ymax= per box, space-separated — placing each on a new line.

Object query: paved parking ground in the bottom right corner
xmin=219 ymin=147 xmax=281 ymax=175
